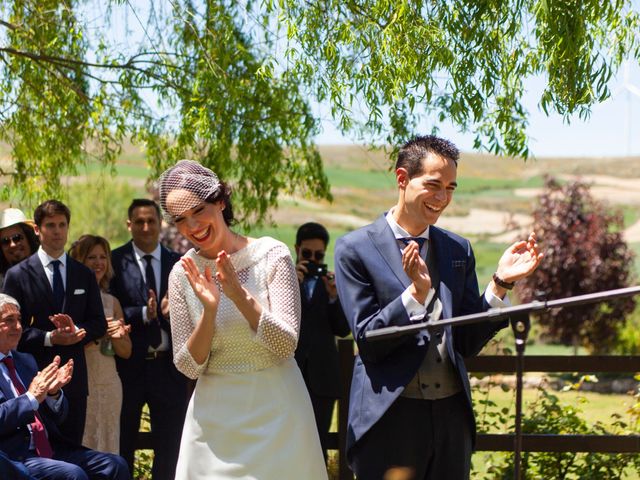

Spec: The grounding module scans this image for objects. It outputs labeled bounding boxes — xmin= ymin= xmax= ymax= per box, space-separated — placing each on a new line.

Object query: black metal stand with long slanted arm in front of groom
xmin=365 ymin=286 xmax=640 ymax=480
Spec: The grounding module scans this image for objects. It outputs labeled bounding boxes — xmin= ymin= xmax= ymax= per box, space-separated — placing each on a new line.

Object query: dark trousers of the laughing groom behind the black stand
xmin=351 ymin=392 xmax=472 ymax=480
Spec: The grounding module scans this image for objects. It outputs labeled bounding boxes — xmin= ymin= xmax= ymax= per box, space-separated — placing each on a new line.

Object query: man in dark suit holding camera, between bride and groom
xmin=295 ymin=222 xmax=349 ymax=459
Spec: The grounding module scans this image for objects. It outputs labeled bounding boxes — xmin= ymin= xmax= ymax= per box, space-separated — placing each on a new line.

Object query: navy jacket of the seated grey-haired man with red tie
xmin=0 ymin=350 xmax=69 ymax=462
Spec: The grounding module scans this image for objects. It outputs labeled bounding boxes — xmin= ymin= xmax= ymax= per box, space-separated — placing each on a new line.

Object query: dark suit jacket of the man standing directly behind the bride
xmin=110 ymin=241 xmax=180 ymax=379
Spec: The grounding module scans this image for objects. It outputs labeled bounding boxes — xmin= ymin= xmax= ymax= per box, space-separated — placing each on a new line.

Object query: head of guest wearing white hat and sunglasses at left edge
xmin=0 ymin=208 xmax=40 ymax=285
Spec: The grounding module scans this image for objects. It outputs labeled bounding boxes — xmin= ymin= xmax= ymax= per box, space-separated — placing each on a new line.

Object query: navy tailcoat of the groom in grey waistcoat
xmin=335 ymin=215 xmax=506 ymax=462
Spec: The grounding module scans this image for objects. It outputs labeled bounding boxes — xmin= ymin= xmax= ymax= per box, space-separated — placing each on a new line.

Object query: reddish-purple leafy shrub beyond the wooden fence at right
xmin=517 ymin=177 xmax=635 ymax=353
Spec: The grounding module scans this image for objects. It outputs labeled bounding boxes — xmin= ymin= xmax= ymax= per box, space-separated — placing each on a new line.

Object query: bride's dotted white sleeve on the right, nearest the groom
xmin=254 ymin=245 xmax=300 ymax=358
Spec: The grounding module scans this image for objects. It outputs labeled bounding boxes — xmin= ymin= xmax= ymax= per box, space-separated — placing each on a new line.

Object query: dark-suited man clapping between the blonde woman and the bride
xmin=111 ymin=198 xmax=188 ymax=480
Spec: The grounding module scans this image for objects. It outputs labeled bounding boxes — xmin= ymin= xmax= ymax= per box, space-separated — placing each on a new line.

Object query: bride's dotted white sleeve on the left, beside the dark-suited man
xmin=169 ymin=263 xmax=209 ymax=379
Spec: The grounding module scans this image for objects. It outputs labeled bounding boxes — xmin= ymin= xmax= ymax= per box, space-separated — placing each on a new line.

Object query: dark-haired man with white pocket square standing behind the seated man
xmin=4 ymin=200 xmax=107 ymax=444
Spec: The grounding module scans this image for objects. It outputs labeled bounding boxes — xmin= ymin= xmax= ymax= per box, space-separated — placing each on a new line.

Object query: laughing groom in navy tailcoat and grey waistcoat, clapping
xmin=335 ymin=136 xmax=542 ymax=480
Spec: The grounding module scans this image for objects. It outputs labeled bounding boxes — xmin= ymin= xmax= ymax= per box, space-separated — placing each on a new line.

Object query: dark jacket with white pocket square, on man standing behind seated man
xmin=4 ymin=253 xmax=107 ymax=397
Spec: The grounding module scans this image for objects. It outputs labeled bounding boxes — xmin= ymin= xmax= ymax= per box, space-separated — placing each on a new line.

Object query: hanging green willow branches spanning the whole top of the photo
xmin=0 ymin=0 xmax=640 ymax=222
